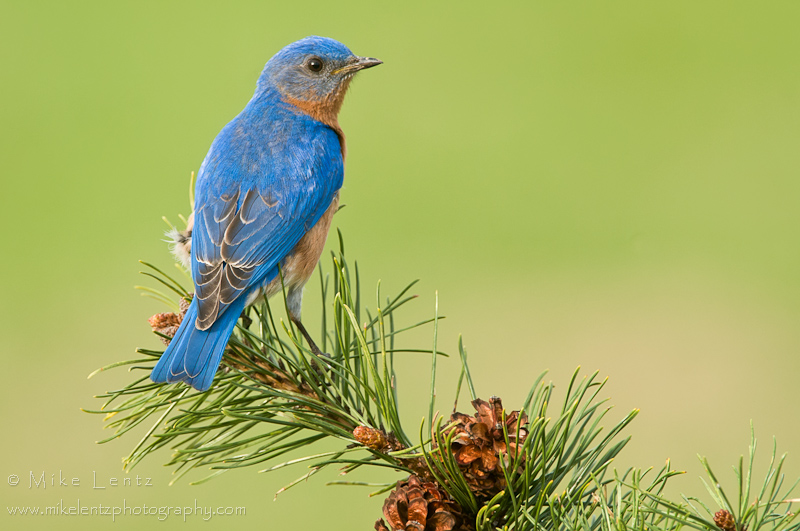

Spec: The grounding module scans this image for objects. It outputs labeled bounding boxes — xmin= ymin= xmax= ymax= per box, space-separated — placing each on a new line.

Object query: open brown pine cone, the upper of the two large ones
xmin=448 ymin=397 xmax=528 ymax=498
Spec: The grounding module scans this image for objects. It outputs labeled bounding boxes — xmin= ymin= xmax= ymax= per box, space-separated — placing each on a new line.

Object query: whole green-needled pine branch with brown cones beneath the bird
xmin=90 ymin=202 xmax=800 ymax=531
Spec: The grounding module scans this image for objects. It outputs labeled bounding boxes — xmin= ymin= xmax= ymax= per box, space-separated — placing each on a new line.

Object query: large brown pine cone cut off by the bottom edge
xmin=375 ymin=476 xmax=471 ymax=531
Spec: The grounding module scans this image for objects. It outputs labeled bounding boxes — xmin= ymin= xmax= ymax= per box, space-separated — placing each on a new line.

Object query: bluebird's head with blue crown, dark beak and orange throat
xmin=258 ymin=37 xmax=382 ymax=122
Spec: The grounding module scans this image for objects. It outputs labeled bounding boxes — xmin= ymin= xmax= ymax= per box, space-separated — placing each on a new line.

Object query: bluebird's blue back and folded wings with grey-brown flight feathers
xmin=192 ymin=119 xmax=343 ymax=330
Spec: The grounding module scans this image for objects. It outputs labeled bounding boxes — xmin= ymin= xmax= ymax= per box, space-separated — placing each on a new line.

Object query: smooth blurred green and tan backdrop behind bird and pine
xmin=0 ymin=0 xmax=800 ymax=529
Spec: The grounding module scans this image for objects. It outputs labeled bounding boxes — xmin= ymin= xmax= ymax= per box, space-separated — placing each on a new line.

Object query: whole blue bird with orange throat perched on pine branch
xmin=155 ymin=37 xmax=381 ymax=391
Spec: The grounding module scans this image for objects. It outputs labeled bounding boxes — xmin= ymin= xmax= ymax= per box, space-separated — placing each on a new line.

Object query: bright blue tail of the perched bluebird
xmin=150 ymin=297 xmax=244 ymax=391
